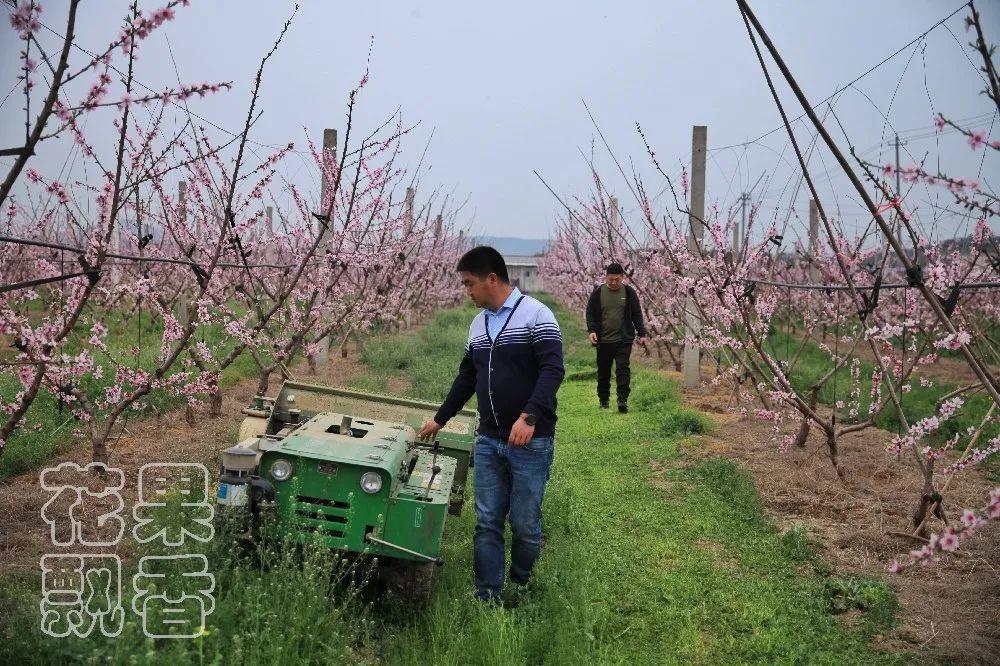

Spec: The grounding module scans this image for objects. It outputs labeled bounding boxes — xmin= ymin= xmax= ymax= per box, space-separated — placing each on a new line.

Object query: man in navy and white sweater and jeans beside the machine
xmin=420 ymin=246 xmax=565 ymax=602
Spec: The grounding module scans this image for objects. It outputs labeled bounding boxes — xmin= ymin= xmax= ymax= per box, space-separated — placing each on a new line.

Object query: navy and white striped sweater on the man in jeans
xmin=434 ymin=296 xmax=565 ymax=439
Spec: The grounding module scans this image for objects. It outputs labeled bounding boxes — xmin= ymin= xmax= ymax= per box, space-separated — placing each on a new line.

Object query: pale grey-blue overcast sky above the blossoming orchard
xmin=0 ymin=0 xmax=1000 ymax=243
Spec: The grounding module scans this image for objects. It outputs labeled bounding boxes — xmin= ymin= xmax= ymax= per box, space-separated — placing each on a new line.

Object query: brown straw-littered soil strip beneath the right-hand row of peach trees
xmin=661 ymin=366 xmax=1000 ymax=664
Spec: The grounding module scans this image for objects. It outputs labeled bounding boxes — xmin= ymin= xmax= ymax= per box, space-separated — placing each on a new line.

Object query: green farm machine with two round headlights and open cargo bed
xmin=217 ymin=381 xmax=477 ymax=601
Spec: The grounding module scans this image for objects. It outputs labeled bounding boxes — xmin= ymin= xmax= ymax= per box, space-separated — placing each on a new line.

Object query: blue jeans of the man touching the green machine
xmin=472 ymin=435 xmax=555 ymax=600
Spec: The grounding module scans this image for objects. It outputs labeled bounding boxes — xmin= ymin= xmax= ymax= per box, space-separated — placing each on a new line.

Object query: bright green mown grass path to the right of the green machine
xmin=380 ymin=300 xmax=894 ymax=664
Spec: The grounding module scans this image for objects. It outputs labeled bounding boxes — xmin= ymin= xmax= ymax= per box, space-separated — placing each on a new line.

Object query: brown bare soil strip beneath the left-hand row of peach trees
xmin=0 ymin=350 xmax=363 ymax=575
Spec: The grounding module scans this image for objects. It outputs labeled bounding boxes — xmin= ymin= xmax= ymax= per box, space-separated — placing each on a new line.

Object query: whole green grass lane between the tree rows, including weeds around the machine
xmin=0 ymin=296 xmax=901 ymax=666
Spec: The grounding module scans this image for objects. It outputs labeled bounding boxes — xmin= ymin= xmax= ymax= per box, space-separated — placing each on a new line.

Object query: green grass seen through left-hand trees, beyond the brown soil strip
xmin=0 ymin=308 xmax=257 ymax=479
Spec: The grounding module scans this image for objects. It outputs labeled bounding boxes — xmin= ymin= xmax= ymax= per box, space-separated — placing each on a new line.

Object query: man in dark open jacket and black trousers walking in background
xmin=587 ymin=263 xmax=646 ymax=414
